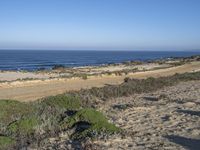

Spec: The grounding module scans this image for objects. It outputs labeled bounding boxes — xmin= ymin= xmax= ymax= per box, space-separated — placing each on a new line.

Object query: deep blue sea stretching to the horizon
xmin=0 ymin=50 xmax=200 ymax=71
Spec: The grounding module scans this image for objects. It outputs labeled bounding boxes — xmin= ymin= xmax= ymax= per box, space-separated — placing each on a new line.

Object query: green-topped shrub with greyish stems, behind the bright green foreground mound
xmin=32 ymin=94 xmax=81 ymax=134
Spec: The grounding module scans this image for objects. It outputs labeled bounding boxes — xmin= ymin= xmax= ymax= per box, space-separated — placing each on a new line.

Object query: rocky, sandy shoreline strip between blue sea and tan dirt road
xmin=0 ymin=55 xmax=200 ymax=83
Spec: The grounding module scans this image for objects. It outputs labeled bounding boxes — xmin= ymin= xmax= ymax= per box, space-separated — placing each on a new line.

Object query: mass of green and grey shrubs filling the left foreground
xmin=0 ymin=94 xmax=120 ymax=149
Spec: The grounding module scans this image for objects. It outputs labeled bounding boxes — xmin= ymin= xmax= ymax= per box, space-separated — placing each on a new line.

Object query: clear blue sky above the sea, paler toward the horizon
xmin=0 ymin=0 xmax=200 ymax=50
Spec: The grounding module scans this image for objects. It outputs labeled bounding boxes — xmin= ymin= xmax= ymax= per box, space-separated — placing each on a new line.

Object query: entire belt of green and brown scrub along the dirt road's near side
xmin=0 ymin=72 xmax=200 ymax=149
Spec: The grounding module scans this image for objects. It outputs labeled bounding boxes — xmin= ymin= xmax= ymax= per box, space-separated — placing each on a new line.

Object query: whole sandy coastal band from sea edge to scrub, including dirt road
xmin=0 ymin=55 xmax=200 ymax=101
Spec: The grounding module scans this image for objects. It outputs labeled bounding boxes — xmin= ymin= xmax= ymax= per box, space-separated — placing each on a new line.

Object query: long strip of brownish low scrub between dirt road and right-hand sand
xmin=76 ymin=72 xmax=200 ymax=101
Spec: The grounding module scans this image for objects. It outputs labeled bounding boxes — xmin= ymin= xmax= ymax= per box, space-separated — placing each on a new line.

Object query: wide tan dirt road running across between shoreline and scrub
xmin=0 ymin=62 xmax=200 ymax=101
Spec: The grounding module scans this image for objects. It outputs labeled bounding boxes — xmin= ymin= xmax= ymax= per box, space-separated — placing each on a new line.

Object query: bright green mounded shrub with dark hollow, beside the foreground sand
xmin=61 ymin=108 xmax=121 ymax=139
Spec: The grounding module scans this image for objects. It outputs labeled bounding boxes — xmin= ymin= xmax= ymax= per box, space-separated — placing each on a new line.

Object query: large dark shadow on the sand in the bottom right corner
xmin=165 ymin=135 xmax=200 ymax=150
